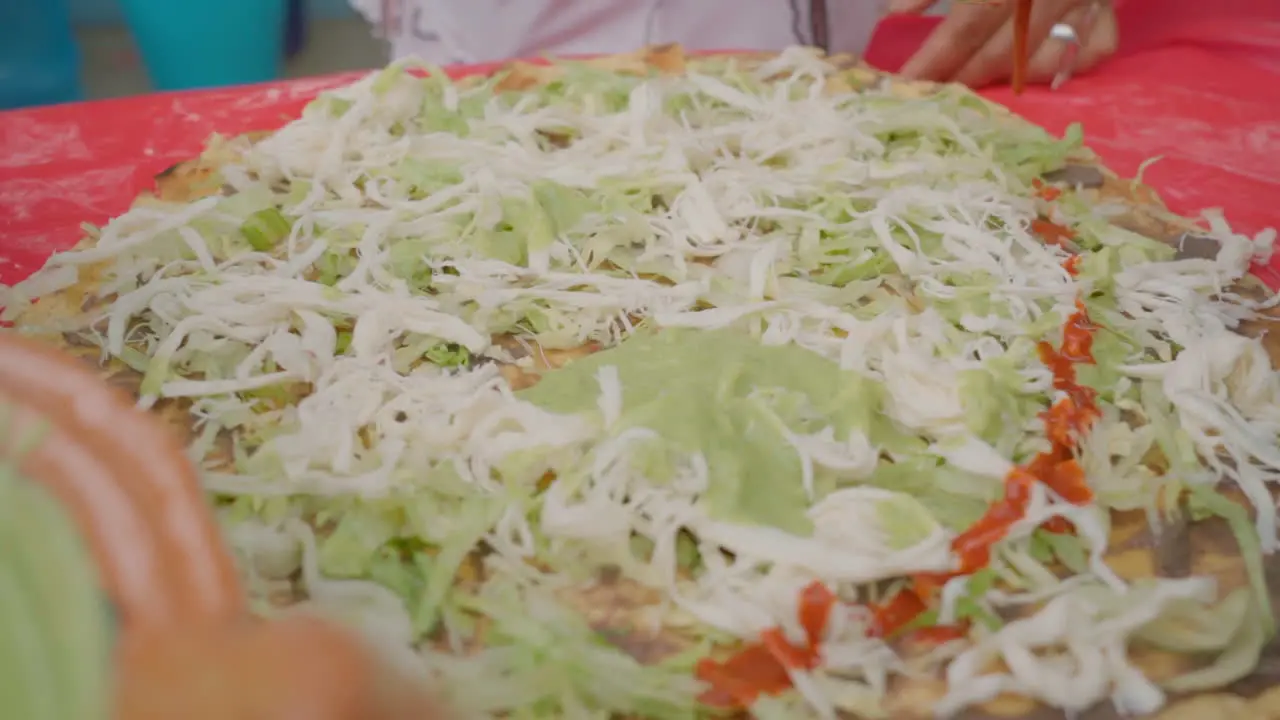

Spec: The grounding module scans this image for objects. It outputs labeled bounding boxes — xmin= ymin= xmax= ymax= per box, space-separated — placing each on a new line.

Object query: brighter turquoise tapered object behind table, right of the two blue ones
xmin=120 ymin=0 xmax=285 ymax=90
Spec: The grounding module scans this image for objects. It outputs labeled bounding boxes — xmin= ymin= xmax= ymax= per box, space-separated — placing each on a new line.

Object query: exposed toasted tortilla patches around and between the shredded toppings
xmin=10 ymin=46 xmax=1280 ymax=720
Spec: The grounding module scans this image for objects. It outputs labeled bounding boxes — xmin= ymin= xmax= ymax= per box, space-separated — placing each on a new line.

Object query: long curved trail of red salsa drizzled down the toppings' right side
xmin=695 ymin=297 xmax=1100 ymax=710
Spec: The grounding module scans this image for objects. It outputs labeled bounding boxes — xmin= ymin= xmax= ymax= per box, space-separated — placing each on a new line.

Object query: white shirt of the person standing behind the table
xmin=351 ymin=0 xmax=884 ymax=65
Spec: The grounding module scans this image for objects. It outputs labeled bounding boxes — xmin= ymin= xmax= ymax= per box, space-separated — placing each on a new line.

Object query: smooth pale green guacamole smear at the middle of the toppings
xmin=520 ymin=328 xmax=879 ymax=536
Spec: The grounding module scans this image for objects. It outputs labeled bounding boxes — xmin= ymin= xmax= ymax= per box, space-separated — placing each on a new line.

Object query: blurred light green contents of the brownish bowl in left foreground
xmin=0 ymin=443 xmax=113 ymax=720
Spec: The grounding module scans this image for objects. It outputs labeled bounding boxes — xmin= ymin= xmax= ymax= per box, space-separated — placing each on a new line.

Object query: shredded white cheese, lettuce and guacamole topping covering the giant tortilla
xmin=5 ymin=49 xmax=1280 ymax=717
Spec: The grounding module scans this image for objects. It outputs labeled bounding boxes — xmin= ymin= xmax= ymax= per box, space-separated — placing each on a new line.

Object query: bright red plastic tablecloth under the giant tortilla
xmin=0 ymin=6 xmax=1280 ymax=287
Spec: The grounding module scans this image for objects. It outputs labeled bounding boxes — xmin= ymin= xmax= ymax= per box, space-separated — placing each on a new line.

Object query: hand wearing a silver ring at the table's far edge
xmin=890 ymin=0 xmax=1119 ymax=87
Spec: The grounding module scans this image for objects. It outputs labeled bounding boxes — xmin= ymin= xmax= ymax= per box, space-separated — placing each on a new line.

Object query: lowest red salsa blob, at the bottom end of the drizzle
xmin=694 ymin=582 xmax=836 ymax=710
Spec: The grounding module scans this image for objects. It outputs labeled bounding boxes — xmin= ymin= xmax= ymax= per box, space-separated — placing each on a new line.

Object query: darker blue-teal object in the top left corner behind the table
xmin=0 ymin=0 xmax=84 ymax=110
